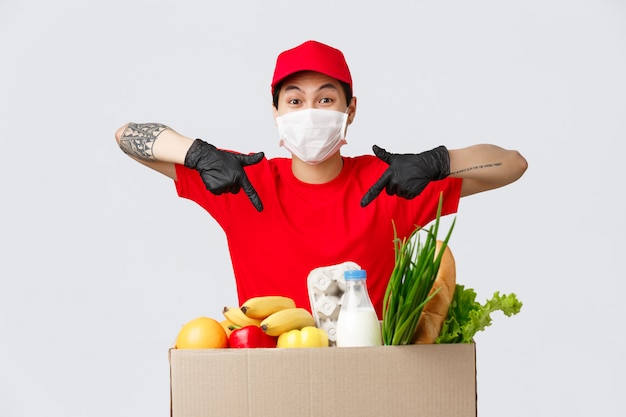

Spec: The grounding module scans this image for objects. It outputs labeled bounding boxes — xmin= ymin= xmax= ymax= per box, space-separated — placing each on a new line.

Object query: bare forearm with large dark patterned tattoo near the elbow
xmin=115 ymin=123 xmax=194 ymax=180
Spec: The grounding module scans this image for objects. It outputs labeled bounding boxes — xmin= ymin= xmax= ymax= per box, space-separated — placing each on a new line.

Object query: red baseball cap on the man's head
xmin=272 ymin=41 xmax=352 ymax=94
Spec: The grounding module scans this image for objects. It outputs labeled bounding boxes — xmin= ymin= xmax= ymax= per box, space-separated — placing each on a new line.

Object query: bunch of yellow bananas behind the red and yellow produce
xmin=223 ymin=295 xmax=315 ymax=336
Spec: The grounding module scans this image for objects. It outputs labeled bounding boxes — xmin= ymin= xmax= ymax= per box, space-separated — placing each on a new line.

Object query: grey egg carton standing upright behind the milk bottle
xmin=307 ymin=261 xmax=361 ymax=346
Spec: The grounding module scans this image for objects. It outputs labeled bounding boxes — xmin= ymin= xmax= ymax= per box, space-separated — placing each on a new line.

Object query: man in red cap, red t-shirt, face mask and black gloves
xmin=115 ymin=41 xmax=527 ymax=318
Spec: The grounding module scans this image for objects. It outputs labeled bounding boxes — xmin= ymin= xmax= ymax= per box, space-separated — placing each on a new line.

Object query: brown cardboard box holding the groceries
xmin=169 ymin=344 xmax=477 ymax=417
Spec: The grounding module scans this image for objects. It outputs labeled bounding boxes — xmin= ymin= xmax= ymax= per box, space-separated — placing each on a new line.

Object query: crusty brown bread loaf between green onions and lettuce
xmin=414 ymin=240 xmax=456 ymax=343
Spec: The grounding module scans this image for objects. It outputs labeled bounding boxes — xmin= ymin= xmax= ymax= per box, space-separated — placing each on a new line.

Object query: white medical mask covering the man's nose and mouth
xmin=276 ymin=109 xmax=348 ymax=165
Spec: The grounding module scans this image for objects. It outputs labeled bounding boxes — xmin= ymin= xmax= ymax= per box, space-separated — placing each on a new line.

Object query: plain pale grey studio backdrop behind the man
xmin=0 ymin=0 xmax=626 ymax=417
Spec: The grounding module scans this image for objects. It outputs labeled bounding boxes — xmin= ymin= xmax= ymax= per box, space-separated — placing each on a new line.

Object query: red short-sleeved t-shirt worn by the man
xmin=176 ymin=155 xmax=462 ymax=318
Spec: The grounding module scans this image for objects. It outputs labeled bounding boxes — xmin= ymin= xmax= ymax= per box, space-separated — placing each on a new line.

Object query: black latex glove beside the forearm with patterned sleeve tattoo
xmin=185 ymin=139 xmax=264 ymax=211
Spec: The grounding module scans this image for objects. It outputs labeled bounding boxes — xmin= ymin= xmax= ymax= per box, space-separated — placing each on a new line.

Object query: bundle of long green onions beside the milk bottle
xmin=382 ymin=195 xmax=456 ymax=345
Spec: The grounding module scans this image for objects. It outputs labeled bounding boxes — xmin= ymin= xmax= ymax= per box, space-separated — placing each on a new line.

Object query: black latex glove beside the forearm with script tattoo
xmin=361 ymin=145 xmax=450 ymax=207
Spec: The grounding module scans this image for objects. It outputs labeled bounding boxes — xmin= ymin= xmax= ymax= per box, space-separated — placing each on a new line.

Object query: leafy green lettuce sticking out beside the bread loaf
xmin=435 ymin=284 xmax=522 ymax=343
